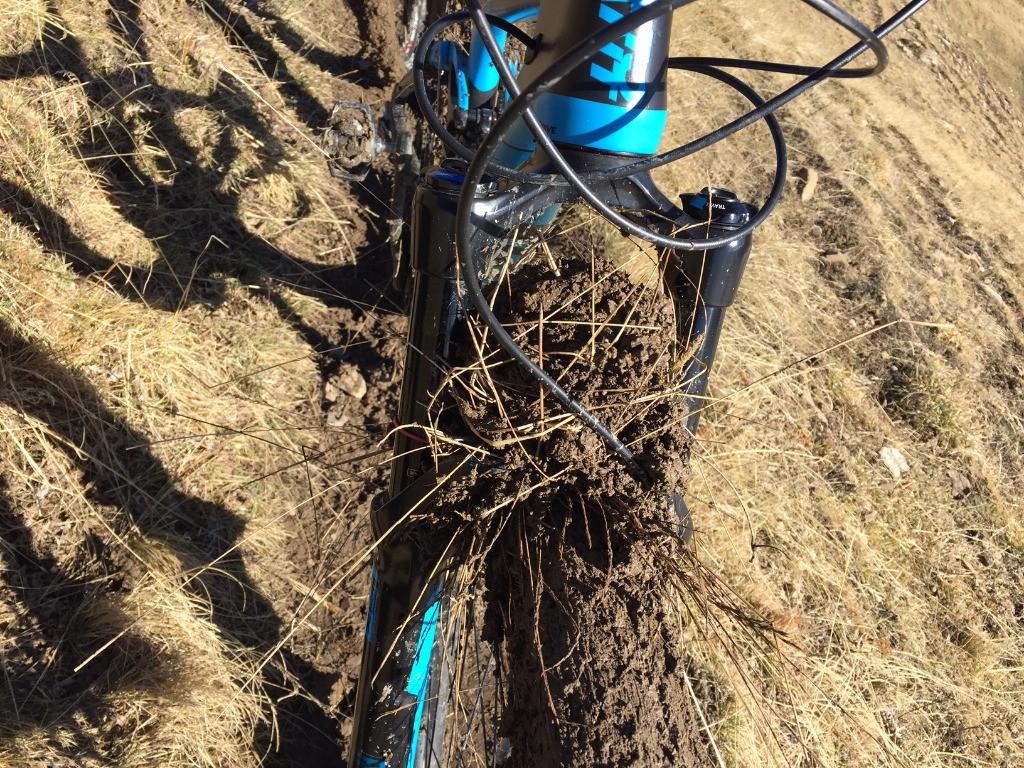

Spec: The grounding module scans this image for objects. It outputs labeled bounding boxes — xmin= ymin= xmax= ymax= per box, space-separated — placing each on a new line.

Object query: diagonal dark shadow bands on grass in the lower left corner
xmin=0 ymin=322 xmax=340 ymax=766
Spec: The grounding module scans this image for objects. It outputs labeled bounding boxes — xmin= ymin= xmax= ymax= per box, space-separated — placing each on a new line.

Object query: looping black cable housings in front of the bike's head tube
xmin=432 ymin=0 xmax=928 ymax=479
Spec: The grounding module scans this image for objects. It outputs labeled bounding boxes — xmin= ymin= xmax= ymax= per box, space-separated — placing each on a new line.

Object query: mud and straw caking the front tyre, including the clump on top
xmin=447 ymin=249 xmax=703 ymax=768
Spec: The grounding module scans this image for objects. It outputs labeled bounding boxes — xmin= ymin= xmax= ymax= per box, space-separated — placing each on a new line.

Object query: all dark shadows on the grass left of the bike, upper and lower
xmin=0 ymin=0 xmax=407 ymax=766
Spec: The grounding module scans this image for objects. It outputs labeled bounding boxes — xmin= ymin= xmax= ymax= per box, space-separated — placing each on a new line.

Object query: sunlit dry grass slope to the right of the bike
xmin=659 ymin=2 xmax=1024 ymax=766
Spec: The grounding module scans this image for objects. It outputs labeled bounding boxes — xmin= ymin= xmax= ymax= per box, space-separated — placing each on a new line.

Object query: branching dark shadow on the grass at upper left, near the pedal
xmin=0 ymin=0 xmax=396 ymax=366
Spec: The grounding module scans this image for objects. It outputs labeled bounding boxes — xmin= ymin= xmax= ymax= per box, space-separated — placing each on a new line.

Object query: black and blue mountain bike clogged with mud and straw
xmin=325 ymin=0 xmax=927 ymax=768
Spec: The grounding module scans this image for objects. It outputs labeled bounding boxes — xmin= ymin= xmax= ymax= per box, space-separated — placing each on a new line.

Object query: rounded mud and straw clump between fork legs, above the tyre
xmin=453 ymin=249 xmax=689 ymax=499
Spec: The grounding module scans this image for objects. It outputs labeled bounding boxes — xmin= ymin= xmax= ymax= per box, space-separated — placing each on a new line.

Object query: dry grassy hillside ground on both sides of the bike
xmin=0 ymin=0 xmax=1024 ymax=768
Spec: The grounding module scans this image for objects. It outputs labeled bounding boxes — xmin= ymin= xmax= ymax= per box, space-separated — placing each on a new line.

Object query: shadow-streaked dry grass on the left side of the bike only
xmin=0 ymin=0 xmax=395 ymax=766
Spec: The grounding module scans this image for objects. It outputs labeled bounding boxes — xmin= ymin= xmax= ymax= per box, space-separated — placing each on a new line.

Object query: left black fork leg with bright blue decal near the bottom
xmin=348 ymin=169 xmax=465 ymax=768
